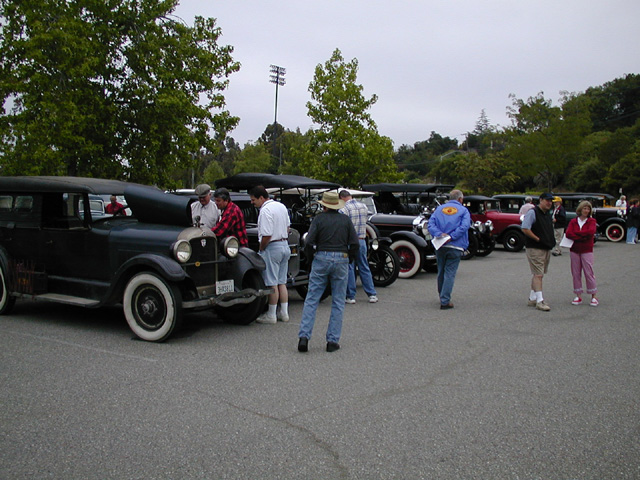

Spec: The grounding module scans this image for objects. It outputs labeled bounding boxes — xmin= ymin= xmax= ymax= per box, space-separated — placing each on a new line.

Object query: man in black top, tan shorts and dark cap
xmin=522 ymin=193 xmax=556 ymax=312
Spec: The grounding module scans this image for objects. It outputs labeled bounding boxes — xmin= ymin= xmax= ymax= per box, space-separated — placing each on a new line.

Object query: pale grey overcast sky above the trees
xmin=175 ymin=0 xmax=640 ymax=149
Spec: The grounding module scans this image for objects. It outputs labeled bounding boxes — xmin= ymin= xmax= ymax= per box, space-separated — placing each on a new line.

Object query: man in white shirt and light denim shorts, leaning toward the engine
xmin=249 ymin=186 xmax=291 ymax=323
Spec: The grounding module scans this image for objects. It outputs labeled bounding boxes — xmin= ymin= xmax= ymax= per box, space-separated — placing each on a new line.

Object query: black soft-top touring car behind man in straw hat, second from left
xmin=215 ymin=173 xmax=400 ymax=290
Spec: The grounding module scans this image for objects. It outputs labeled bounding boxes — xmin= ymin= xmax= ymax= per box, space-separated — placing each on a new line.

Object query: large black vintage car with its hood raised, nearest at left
xmin=0 ymin=177 xmax=269 ymax=342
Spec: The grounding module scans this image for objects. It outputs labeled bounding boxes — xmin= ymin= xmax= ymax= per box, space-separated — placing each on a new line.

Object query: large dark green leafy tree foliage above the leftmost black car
xmin=0 ymin=0 xmax=239 ymax=185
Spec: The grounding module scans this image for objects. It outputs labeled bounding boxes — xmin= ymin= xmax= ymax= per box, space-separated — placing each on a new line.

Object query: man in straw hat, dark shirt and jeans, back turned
xmin=298 ymin=191 xmax=359 ymax=352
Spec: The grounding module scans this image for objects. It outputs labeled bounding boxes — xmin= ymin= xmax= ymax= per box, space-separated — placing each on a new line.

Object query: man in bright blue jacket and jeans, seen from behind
xmin=428 ymin=190 xmax=471 ymax=310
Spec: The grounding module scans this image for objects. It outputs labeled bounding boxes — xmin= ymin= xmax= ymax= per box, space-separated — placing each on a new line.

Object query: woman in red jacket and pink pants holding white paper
xmin=565 ymin=200 xmax=598 ymax=307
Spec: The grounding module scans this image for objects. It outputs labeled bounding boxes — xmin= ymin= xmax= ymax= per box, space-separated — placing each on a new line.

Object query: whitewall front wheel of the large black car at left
xmin=122 ymin=272 xmax=182 ymax=342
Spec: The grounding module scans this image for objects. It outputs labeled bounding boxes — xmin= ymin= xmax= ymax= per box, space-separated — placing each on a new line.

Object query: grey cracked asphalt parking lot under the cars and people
xmin=0 ymin=241 xmax=640 ymax=480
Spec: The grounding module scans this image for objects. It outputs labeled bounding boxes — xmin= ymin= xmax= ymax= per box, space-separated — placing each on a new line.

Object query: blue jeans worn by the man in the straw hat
xmin=298 ymin=252 xmax=349 ymax=343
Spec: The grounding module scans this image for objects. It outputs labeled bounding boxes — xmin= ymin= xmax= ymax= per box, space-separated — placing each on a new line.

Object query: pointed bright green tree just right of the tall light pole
xmin=300 ymin=49 xmax=401 ymax=187
